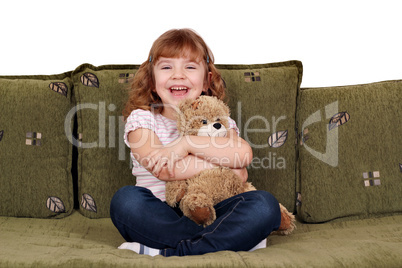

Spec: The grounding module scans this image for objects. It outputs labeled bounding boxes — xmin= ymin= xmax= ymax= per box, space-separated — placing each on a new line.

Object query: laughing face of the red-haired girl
xmin=153 ymin=57 xmax=211 ymax=119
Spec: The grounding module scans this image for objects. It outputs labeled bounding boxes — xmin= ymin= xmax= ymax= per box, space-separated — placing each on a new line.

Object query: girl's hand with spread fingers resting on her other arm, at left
xmin=144 ymin=138 xmax=189 ymax=178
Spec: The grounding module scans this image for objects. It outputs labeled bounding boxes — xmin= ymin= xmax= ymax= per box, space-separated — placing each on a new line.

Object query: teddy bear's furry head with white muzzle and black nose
xmin=177 ymin=96 xmax=230 ymax=137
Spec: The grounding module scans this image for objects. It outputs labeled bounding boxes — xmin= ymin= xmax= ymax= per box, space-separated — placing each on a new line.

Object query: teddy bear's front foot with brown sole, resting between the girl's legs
xmin=180 ymin=193 xmax=216 ymax=227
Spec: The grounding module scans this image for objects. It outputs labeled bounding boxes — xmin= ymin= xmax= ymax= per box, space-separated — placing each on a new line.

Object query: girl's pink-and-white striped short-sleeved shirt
xmin=124 ymin=109 xmax=239 ymax=201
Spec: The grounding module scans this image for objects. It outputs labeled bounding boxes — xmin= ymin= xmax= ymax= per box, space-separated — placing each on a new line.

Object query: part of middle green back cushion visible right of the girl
xmin=217 ymin=61 xmax=303 ymax=211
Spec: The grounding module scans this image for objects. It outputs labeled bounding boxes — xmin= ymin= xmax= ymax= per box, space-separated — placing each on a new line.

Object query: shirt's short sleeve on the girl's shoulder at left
xmin=124 ymin=109 xmax=157 ymax=147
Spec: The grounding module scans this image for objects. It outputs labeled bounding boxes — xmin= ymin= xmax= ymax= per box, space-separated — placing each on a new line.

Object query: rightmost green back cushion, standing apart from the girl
xmin=297 ymin=81 xmax=402 ymax=222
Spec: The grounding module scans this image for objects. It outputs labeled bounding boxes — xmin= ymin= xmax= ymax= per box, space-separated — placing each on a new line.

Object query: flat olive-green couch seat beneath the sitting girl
xmin=0 ymin=212 xmax=402 ymax=268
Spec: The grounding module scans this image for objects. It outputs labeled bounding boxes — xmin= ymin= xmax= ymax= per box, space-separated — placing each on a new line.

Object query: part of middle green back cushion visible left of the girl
xmin=72 ymin=64 xmax=138 ymax=218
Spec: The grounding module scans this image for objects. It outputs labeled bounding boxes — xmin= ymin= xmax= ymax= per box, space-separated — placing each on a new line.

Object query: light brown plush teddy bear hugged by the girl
xmin=166 ymin=96 xmax=295 ymax=235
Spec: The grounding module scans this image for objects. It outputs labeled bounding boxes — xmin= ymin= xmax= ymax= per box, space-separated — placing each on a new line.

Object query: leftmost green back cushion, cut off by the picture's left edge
xmin=0 ymin=73 xmax=74 ymax=218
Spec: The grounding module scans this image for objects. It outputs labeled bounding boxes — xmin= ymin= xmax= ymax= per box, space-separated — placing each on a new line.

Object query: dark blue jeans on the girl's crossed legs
xmin=110 ymin=186 xmax=281 ymax=256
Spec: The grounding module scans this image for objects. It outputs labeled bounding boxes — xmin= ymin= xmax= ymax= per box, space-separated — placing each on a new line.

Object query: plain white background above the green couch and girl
xmin=0 ymin=0 xmax=402 ymax=87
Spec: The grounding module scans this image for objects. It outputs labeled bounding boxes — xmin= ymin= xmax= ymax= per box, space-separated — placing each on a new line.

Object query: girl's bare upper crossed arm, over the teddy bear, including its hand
xmin=143 ymin=129 xmax=252 ymax=178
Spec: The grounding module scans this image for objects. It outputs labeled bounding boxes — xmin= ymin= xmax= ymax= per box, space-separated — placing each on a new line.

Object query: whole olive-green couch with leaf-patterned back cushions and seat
xmin=0 ymin=61 xmax=402 ymax=268
